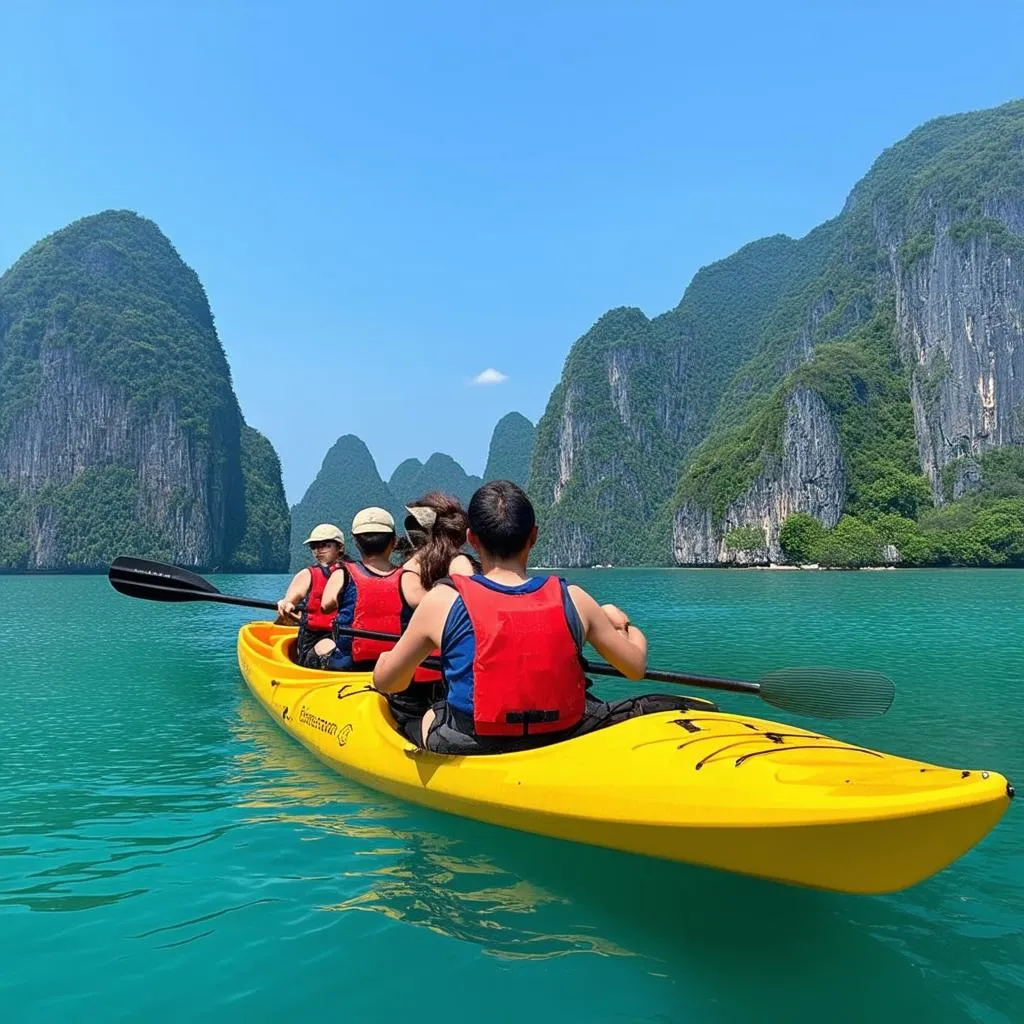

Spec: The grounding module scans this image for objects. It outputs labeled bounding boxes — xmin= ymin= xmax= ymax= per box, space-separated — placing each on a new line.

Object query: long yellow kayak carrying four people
xmin=239 ymin=623 xmax=1013 ymax=893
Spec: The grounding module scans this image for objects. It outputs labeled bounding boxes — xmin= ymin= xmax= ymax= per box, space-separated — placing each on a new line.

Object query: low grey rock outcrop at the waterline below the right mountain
xmin=673 ymin=388 xmax=846 ymax=565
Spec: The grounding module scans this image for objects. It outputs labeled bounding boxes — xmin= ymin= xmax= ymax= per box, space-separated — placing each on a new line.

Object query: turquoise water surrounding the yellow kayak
xmin=0 ymin=570 xmax=1024 ymax=1024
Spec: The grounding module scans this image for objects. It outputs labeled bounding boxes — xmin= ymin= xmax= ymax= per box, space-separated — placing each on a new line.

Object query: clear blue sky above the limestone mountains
xmin=0 ymin=0 xmax=1024 ymax=502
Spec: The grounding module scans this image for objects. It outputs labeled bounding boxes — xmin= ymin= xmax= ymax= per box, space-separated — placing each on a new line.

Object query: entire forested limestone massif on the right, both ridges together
xmin=529 ymin=102 xmax=1024 ymax=565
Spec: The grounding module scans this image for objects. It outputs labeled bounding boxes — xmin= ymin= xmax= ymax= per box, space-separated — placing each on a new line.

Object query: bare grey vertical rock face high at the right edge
xmin=889 ymin=197 xmax=1024 ymax=502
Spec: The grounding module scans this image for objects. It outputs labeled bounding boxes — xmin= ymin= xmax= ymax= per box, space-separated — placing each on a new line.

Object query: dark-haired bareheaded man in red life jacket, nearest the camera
xmin=374 ymin=480 xmax=655 ymax=754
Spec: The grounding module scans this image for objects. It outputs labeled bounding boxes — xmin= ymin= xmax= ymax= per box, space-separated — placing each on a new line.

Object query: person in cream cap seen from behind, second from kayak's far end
xmin=315 ymin=506 xmax=402 ymax=672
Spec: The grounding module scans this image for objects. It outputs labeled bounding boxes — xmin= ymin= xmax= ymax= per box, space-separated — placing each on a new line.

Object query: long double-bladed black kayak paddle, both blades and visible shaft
xmin=108 ymin=557 xmax=896 ymax=718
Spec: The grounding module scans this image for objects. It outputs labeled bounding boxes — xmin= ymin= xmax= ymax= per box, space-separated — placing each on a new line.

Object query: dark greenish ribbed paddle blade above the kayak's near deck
xmin=760 ymin=668 xmax=896 ymax=718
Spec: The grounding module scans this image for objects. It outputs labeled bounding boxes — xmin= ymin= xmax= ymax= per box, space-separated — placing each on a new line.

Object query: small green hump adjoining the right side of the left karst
xmin=227 ymin=424 xmax=291 ymax=572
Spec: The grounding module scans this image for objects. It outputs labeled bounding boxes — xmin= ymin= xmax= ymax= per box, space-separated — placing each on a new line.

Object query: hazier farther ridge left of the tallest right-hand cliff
xmin=528 ymin=237 xmax=823 ymax=565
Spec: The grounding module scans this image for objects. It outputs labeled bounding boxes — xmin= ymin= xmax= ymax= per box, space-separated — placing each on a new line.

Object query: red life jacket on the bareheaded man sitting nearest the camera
xmin=452 ymin=575 xmax=587 ymax=736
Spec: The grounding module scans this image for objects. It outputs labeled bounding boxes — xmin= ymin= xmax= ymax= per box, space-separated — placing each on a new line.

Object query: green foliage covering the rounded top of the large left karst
xmin=0 ymin=210 xmax=238 ymax=446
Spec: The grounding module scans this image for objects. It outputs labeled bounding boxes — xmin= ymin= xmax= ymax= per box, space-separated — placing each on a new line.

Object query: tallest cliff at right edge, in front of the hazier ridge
xmin=655 ymin=102 xmax=1024 ymax=564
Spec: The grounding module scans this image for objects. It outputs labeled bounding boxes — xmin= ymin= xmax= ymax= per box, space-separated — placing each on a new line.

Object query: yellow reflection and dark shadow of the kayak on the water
xmin=228 ymin=688 xmax=968 ymax=1021
